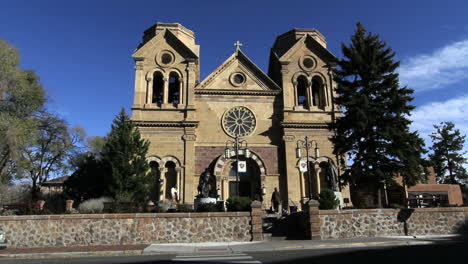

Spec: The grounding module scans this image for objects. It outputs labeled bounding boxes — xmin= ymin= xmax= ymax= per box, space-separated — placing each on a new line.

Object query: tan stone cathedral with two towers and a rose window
xmin=132 ymin=23 xmax=349 ymax=208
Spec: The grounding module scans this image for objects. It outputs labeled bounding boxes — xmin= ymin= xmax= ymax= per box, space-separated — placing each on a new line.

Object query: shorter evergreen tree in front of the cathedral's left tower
xmin=101 ymin=109 xmax=151 ymax=202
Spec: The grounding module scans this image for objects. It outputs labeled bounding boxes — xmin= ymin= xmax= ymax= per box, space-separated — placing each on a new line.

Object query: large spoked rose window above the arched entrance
xmin=222 ymin=106 xmax=257 ymax=137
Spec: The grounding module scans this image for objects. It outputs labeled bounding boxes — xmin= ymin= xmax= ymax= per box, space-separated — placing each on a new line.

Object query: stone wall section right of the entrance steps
xmin=318 ymin=207 xmax=468 ymax=239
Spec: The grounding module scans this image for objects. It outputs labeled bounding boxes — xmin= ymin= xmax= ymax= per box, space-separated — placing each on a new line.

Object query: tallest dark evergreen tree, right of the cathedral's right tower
xmin=332 ymin=23 xmax=424 ymax=206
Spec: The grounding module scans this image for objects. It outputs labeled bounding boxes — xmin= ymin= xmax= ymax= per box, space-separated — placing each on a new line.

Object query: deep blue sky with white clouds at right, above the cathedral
xmin=0 ymin=0 xmax=468 ymax=154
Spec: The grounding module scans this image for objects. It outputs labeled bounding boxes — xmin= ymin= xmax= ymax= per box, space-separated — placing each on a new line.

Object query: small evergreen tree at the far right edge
xmin=429 ymin=122 xmax=468 ymax=184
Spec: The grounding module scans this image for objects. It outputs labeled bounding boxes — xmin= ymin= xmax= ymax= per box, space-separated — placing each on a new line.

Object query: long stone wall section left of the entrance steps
xmin=0 ymin=212 xmax=252 ymax=248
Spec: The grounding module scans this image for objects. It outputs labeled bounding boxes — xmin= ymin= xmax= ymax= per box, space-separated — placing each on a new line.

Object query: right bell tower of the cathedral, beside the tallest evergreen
xmin=268 ymin=28 xmax=338 ymax=204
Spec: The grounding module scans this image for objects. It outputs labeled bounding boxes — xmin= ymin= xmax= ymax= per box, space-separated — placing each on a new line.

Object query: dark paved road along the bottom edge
xmin=0 ymin=243 xmax=468 ymax=264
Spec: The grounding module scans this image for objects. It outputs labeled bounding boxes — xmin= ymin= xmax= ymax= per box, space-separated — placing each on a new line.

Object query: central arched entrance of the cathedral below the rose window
xmin=214 ymin=150 xmax=266 ymax=200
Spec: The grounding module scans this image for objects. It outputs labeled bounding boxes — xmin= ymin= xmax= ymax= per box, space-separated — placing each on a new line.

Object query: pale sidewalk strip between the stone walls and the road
xmin=0 ymin=235 xmax=456 ymax=259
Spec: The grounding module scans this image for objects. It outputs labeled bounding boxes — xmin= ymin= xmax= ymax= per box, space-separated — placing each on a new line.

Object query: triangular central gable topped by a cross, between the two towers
xmin=195 ymin=49 xmax=281 ymax=92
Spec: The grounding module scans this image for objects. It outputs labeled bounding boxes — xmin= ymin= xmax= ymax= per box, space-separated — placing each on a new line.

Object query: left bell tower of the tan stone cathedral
xmin=132 ymin=22 xmax=200 ymax=204
